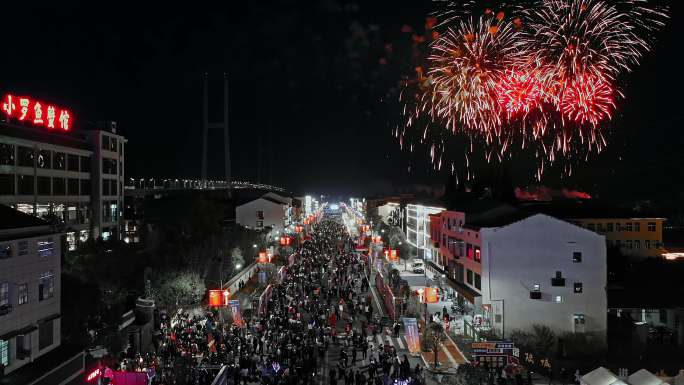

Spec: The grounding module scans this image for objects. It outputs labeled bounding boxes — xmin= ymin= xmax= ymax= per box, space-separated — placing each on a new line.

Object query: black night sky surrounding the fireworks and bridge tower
xmin=0 ymin=0 xmax=684 ymax=195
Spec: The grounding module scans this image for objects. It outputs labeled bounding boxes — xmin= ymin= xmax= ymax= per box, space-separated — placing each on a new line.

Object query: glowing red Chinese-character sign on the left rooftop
xmin=0 ymin=94 xmax=73 ymax=131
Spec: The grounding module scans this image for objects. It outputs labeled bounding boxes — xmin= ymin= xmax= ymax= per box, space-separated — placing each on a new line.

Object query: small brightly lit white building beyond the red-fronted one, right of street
xmin=406 ymin=204 xmax=444 ymax=261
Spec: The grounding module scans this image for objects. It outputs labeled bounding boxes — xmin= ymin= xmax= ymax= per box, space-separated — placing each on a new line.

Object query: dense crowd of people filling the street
xmin=139 ymin=219 xmax=422 ymax=385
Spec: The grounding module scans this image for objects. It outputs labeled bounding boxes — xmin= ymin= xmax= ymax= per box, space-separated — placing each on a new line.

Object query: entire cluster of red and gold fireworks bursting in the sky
xmin=395 ymin=0 xmax=667 ymax=178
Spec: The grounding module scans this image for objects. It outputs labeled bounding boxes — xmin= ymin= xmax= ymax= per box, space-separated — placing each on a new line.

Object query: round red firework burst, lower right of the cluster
xmin=560 ymin=74 xmax=615 ymax=127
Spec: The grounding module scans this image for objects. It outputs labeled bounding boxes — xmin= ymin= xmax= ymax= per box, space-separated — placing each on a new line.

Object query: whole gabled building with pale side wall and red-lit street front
xmin=431 ymin=205 xmax=607 ymax=338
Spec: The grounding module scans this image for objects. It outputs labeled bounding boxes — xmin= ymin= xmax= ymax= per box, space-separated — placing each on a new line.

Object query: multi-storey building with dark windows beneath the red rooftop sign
xmin=0 ymin=96 xmax=126 ymax=249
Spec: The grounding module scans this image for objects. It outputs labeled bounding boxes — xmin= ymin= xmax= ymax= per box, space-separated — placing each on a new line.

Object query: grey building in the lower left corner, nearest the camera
xmin=0 ymin=205 xmax=85 ymax=384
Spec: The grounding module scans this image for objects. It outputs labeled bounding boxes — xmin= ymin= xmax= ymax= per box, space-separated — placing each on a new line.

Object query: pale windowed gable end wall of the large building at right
xmin=481 ymin=214 xmax=607 ymax=337
